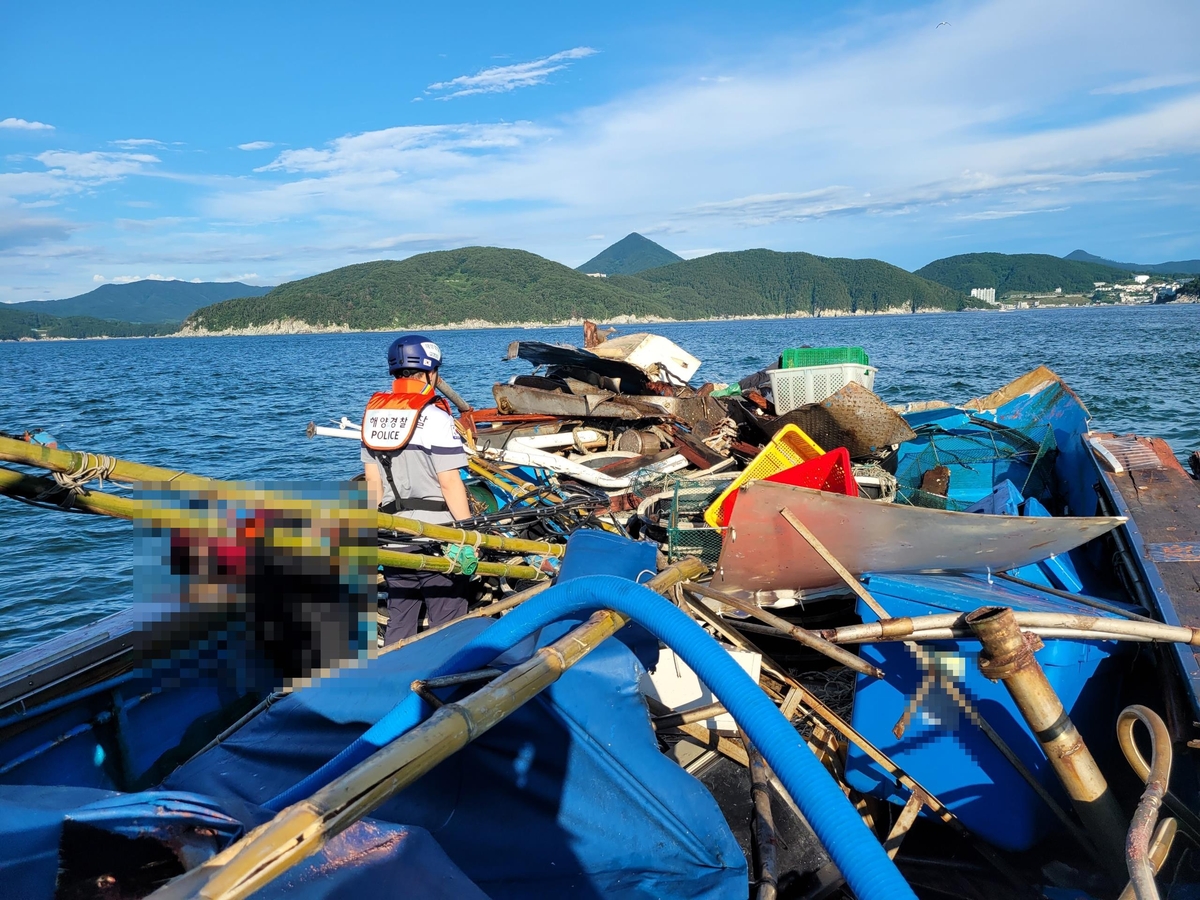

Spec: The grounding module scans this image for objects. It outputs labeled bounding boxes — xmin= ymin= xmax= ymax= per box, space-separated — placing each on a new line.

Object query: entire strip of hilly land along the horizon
xmin=0 ymin=233 xmax=1196 ymax=341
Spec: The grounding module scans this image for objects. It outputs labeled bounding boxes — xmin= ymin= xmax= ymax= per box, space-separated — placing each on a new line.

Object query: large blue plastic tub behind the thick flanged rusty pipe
xmin=846 ymin=575 xmax=1132 ymax=851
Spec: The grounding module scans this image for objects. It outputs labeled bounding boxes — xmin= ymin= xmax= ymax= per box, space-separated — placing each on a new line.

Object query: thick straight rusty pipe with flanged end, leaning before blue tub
xmin=966 ymin=606 xmax=1126 ymax=881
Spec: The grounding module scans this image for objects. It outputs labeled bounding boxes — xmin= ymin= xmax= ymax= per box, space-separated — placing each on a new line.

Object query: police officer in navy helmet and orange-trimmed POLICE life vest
xmin=362 ymin=335 xmax=470 ymax=644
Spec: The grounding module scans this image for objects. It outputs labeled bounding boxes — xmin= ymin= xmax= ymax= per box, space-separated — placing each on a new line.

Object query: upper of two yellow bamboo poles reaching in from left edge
xmin=0 ymin=437 xmax=566 ymax=557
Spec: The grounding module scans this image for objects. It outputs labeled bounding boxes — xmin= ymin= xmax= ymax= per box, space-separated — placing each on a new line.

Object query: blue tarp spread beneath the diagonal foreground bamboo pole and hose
xmin=167 ymin=620 xmax=746 ymax=900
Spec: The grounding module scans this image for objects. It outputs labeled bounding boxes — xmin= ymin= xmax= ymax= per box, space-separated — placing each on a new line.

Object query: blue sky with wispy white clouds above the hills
xmin=0 ymin=0 xmax=1200 ymax=302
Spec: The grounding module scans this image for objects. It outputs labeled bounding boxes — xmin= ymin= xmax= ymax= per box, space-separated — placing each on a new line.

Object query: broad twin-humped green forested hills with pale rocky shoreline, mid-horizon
xmin=185 ymin=247 xmax=982 ymax=331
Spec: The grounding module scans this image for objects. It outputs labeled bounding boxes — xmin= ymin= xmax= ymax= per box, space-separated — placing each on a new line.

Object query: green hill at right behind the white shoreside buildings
xmin=916 ymin=253 xmax=1130 ymax=296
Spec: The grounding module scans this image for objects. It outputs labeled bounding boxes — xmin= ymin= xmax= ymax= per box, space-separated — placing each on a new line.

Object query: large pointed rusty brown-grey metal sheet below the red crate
xmin=713 ymin=481 xmax=1126 ymax=592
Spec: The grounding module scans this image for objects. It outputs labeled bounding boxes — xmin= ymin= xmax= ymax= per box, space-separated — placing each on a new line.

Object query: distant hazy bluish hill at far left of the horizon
xmin=10 ymin=278 xmax=270 ymax=323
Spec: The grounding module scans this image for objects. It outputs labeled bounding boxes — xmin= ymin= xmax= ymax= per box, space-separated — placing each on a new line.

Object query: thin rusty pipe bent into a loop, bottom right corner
xmin=1117 ymin=706 xmax=1172 ymax=900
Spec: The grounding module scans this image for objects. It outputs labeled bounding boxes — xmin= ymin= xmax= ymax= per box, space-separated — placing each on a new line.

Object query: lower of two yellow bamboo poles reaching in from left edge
xmin=0 ymin=466 xmax=547 ymax=581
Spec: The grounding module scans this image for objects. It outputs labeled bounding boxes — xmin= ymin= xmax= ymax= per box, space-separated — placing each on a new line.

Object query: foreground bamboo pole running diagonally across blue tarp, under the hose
xmin=150 ymin=559 xmax=704 ymax=900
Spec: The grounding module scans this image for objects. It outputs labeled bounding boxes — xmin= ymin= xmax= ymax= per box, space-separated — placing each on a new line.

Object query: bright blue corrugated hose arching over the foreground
xmin=265 ymin=575 xmax=916 ymax=900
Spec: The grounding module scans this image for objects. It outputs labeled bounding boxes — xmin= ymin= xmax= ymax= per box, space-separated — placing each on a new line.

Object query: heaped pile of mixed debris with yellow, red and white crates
xmin=463 ymin=323 xmax=914 ymax=562
